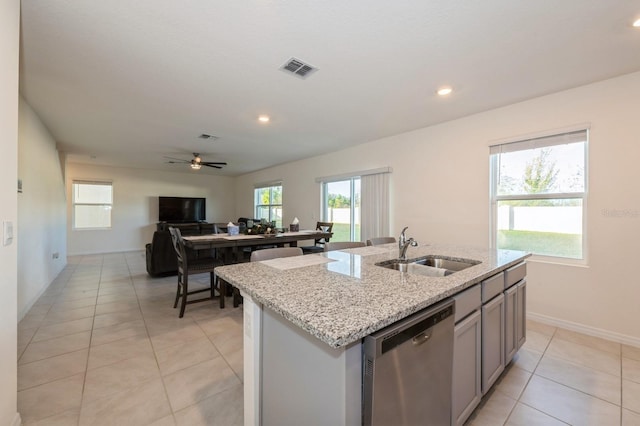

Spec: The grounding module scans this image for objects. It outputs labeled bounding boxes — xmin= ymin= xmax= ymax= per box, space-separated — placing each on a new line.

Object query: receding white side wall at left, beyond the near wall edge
xmin=18 ymin=97 xmax=67 ymax=319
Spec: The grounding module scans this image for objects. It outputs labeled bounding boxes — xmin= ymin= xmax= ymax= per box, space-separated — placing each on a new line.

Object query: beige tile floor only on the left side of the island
xmin=18 ymin=252 xmax=243 ymax=426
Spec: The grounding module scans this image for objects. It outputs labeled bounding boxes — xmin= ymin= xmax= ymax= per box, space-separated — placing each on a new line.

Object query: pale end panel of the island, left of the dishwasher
xmin=242 ymin=293 xmax=362 ymax=426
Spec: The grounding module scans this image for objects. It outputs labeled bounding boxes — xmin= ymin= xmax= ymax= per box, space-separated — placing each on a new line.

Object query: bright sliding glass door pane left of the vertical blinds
xmin=322 ymin=177 xmax=361 ymax=241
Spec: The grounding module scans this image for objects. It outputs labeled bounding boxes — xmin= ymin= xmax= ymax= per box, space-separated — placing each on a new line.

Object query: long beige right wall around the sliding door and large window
xmin=236 ymin=73 xmax=640 ymax=346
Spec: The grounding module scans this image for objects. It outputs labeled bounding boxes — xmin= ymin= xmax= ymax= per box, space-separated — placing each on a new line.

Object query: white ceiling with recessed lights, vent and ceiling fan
xmin=20 ymin=0 xmax=640 ymax=175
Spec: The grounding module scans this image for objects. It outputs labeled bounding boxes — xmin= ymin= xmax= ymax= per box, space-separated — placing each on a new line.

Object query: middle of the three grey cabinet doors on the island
xmin=482 ymin=293 xmax=504 ymax=395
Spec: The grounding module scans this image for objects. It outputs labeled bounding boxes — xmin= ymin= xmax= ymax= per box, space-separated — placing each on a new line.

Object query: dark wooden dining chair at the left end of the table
xmin=169 ymin=227 xmax=226 ymax=318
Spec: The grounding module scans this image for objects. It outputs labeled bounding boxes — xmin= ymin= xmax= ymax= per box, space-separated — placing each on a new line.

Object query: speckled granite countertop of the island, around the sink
xmin=216 ymin=243 xmax=529 ymax=348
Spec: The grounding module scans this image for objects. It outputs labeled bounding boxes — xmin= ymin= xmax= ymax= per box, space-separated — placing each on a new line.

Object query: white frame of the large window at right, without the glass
xmin=489 ymin=130 xmax=590 ymax=265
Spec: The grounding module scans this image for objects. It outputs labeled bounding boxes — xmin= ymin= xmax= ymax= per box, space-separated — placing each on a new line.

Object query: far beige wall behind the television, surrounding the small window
xmin=66 ymin=163 xmax=237 ymax=255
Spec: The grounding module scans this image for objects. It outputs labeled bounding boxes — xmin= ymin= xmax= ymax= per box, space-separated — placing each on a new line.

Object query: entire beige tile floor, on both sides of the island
xmin=18 ymin=252 xmax=640 ymax=426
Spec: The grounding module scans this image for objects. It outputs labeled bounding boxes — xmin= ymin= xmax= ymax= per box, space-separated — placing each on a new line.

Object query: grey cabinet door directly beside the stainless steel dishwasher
xmin=451 ymin=310 xmax=482 ymax=426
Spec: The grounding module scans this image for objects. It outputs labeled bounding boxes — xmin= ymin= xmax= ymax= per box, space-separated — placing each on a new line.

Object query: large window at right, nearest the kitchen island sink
xmin=490 ymin=130 xmax=588 ymax=259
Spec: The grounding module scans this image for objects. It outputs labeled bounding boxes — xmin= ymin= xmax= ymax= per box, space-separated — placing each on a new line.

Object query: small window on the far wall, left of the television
xmin=72 ymin=181 xmax=113 ymax=229
